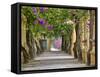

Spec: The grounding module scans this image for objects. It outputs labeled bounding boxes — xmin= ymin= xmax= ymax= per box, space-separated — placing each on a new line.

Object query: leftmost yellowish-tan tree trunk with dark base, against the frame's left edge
xmin=21 ymin=14 xmax=30 ymax=63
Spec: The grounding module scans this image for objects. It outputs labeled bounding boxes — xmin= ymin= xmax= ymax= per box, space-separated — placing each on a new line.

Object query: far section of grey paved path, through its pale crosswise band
xmin=35 ymin=51 xmax=74 ymax=60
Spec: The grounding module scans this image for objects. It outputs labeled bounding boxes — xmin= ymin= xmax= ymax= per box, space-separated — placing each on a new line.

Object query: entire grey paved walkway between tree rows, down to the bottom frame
xmin=22 ymin=51 xmax=86 ymax=71
